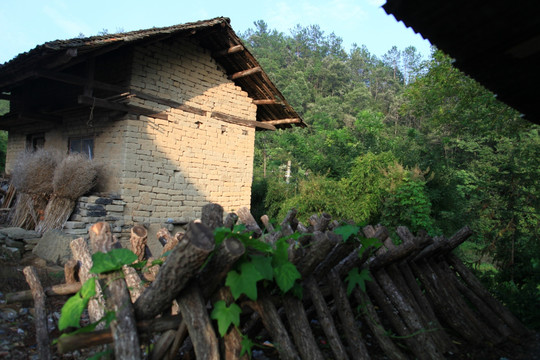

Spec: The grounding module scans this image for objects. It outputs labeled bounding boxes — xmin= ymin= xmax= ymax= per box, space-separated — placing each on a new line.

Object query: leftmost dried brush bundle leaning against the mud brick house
xmin=10 ymin=149 xmax=62 ymax=229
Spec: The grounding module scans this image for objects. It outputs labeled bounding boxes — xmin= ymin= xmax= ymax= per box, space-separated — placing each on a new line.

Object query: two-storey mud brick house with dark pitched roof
xmin=0 ymin=18 xmax=305 ymax=238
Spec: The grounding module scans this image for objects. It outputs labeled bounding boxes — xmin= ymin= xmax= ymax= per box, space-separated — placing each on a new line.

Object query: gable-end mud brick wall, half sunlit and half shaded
xmin=121 ymin=41 xmax=257 ymax=223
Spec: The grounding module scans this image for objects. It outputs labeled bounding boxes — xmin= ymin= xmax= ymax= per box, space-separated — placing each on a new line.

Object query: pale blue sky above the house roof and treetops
xmin=0 ymin=0 xmax=430 ymax=64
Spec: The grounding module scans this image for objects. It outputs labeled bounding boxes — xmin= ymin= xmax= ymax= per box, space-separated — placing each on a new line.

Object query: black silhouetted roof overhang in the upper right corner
xmin=383 ymin=0 xmax=540 ymax=123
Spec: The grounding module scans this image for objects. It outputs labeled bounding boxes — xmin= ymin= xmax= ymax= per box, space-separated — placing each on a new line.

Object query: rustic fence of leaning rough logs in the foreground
xmin=8 ymin=204 xmax=530 ymax=360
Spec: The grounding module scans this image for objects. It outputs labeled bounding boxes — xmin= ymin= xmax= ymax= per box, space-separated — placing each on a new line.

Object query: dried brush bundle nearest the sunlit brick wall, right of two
xmin=36 ymin=154 xmax=97 ymax=233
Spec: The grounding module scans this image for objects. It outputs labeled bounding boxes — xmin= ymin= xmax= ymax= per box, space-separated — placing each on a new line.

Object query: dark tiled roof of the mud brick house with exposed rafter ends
xmin=0 ymin=17 xmax=305 ymax=127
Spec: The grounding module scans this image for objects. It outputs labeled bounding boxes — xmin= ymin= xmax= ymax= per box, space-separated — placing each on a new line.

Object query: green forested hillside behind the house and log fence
xmin=242 ymin=21 xmax=540 ymax=328
